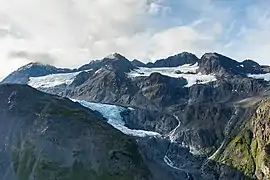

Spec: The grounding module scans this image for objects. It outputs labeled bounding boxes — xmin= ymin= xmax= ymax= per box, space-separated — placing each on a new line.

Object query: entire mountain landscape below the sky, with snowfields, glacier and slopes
xmin=0 ymin=52 xmax=270 ymax=180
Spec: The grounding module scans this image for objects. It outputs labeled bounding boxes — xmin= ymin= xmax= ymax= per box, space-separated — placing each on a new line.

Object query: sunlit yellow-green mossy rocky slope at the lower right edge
xmin=215 ymin=99 xmax=270 ymax=179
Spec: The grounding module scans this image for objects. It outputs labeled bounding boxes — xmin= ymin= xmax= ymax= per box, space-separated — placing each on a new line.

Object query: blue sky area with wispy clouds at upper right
xmin=149 ymin=0 xmax=270 ymax=64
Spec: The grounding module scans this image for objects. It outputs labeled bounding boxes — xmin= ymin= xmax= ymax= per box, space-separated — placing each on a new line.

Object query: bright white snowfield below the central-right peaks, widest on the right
xmin=127 ymin=63 xmax=216 ymax=87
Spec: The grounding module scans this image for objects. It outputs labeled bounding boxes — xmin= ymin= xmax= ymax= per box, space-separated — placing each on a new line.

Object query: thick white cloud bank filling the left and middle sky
xmin=0 ymin=0 xmax=216 ymax=80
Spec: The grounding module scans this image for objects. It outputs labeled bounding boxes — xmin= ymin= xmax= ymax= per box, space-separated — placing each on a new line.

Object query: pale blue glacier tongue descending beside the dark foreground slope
xmin=72 ymin=99 xmax=161 ymax=137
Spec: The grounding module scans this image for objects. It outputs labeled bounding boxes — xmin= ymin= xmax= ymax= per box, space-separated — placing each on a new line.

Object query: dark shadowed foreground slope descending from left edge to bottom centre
xmin=0 ymin=85 xmax=151 ymax=180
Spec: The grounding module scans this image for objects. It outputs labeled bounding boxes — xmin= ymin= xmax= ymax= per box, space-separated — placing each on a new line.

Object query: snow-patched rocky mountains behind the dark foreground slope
xmin=2 ymin=52 xmax=270 ymax=180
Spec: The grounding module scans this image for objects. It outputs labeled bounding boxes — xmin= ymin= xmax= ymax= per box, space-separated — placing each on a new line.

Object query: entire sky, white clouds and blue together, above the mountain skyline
xmin=0 ymin=0 xmax=270 ymax=77
